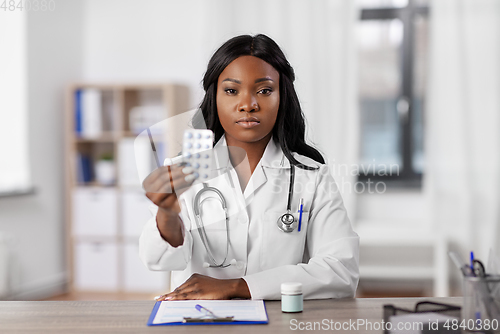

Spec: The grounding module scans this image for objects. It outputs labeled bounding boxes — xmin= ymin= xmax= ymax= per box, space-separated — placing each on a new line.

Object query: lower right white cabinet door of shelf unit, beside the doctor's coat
xmin=122 ymin=243 xmax=170 ymax=294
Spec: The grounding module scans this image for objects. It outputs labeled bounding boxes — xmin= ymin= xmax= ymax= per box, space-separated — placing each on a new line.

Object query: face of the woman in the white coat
xmin=217 ymin=56 xmax=280 ymax=146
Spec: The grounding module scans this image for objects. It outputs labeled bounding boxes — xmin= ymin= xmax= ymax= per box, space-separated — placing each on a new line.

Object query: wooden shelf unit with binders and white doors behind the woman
xmin=65 ymin=83 xmax=188 ymax=292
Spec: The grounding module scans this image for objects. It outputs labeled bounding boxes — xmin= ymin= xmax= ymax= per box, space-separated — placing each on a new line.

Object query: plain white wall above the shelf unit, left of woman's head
xmin=83 ymin=0 xmax=211 ymax=108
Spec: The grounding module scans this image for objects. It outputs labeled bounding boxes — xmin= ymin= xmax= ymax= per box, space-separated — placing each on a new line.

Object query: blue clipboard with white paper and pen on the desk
xmin=147 ymin=300 xmax=269 ymax=326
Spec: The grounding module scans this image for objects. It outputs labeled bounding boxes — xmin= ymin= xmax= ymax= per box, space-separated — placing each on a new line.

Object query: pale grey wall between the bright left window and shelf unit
xmin=0 ymin=1 xmax=83 ymax=299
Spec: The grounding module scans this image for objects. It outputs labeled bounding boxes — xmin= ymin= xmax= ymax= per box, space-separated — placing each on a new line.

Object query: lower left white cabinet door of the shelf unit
xmin=74 ymin=241 xmax=118 ymax=291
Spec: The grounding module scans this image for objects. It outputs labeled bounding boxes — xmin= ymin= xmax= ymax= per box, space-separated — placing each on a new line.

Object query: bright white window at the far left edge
xmin=0 ymin=10 xmax=31 ymax=196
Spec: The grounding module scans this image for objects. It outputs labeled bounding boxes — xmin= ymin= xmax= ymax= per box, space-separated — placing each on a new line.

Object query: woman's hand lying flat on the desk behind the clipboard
xmin=156 ymin=274 xmax=251 ymax=301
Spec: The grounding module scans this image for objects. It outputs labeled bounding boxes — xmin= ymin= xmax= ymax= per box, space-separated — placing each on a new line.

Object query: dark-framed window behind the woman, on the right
xmin=358 ymin=0 xmax=429 ymax=187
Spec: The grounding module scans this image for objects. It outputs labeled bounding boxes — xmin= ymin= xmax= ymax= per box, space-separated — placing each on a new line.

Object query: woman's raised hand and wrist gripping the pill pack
xmin=142 ymin=165 xmax=196 ymax=247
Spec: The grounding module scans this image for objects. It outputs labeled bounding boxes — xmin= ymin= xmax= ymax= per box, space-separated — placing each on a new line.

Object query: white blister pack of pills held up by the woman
xmin=182 ymin=129 xmax=214 ymax=181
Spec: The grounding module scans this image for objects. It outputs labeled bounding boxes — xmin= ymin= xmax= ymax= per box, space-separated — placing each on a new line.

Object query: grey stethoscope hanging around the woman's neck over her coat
xmin=193 ymin=164 xmax=295 ymax=268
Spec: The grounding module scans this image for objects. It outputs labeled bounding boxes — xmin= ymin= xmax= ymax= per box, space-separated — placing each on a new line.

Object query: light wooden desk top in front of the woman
xmin=0 ymin=297 xmax=462 ymax=334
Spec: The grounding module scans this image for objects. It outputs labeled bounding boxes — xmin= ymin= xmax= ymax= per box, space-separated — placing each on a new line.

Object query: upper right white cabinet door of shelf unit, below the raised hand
xmin=121 ymin=190 xmax=153 ymax=240
